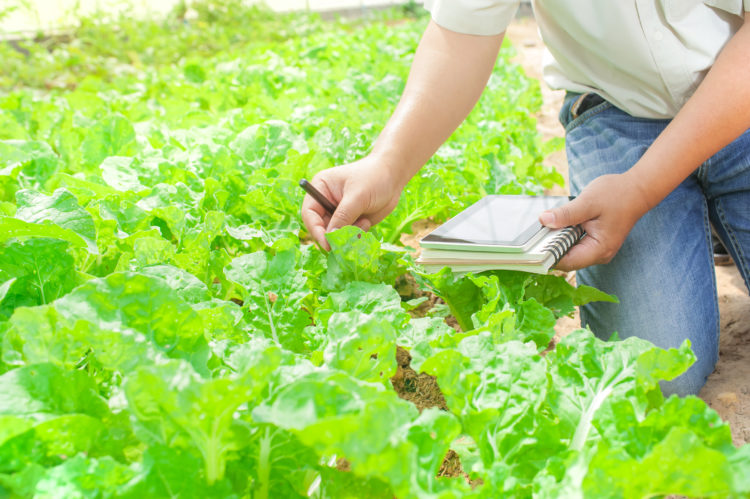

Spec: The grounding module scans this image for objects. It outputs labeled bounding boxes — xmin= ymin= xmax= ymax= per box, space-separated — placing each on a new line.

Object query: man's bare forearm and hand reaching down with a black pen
xmin=301 ymin=22 xmax=503 ymax=249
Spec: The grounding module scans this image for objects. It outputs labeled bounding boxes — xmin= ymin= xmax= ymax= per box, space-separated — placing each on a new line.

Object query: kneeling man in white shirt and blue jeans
xmin=302 ymin=0 xmax=750 ymax=395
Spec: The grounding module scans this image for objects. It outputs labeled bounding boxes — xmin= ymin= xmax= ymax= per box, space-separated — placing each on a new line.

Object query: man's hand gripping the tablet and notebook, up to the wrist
xmin=539 ymin=174 xmax=649 ymax=270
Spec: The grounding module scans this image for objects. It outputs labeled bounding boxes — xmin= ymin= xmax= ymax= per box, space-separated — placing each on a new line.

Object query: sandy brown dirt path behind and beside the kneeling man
xmin=507 ymin=18 xmax=750 ymax=445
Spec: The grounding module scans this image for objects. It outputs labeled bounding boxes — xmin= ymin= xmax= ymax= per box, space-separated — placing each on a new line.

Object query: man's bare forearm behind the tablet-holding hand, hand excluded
xmin=626 ymin=14 xmax=750 ymax=211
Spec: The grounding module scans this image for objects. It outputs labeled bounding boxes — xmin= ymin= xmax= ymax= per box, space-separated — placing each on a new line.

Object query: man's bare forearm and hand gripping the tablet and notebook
xmin=540 ymin=13 xmax=750 ymax=270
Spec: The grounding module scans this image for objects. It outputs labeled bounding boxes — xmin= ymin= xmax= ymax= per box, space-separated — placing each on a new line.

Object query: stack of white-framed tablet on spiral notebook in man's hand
xmin=417 ymin=195 xmax=584 ymax=274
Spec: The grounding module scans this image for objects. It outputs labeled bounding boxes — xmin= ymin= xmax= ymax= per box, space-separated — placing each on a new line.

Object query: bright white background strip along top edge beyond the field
xmin=0 ymin=0 xmax=421 ymax=36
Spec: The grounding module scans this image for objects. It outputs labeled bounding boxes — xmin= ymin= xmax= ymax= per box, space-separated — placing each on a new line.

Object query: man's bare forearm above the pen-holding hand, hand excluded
xmin=372 ymin=22 xmax=503 ymax=185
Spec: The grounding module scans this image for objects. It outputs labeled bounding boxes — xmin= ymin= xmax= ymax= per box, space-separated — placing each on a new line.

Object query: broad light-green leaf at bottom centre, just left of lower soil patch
xmin=252 ymin=371 xmax=460 ymax=496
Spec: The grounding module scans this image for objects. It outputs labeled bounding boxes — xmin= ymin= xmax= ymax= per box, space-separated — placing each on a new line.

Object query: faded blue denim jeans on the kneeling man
xmin=560 ymin=94 xmax=750 ymax=395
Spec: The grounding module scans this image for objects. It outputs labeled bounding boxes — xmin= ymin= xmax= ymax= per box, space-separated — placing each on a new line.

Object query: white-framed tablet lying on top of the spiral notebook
xmin=420 ymin=195 xmax=569 ymax=252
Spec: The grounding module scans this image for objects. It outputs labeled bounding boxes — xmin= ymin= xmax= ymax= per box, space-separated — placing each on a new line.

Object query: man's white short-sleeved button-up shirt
xmin=425 ymin=0 xmax=750 ymax=118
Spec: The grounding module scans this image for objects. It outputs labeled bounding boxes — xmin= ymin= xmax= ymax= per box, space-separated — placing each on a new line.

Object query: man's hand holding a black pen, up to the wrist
xmin=301 ymin=156 xmax=404 ymax=251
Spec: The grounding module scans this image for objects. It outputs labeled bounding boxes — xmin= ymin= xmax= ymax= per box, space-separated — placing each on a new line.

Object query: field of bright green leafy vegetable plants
xmin=0 ymin=0 xmax=750 ymax=499
